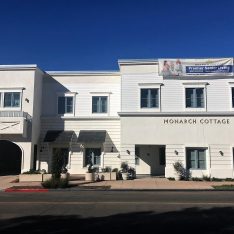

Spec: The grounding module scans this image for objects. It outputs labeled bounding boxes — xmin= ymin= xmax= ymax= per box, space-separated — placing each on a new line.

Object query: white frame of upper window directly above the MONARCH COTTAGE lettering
xmin=183 ymin=82 xmax=208 ymax=112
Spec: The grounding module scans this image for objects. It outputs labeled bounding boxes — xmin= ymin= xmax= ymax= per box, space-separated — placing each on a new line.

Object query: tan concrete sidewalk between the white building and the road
xmin=0 ymin=176 xmax=234 ymax=191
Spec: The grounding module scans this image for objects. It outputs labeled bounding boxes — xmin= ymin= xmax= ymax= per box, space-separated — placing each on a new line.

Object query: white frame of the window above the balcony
xmin=0 ymin=88 xmax=24 ymax=111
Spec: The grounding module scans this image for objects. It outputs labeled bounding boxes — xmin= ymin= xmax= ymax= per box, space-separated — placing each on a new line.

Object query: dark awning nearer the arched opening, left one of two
xmin=44 ymin=130 xmax=74 ymax=143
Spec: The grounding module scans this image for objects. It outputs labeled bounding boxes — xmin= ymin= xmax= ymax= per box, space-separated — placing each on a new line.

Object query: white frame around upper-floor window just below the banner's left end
xmin=138 ymin=83 xmax=163 ymax=112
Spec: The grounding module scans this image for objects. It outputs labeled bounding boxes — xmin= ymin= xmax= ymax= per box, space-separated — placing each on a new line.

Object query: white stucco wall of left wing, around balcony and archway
xmin=0 ymin=66 xmax=42 ymax=172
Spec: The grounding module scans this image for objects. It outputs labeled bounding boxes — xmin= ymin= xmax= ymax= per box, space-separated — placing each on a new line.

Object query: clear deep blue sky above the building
xmin=0 ymin=0 xmax=234 ymax=70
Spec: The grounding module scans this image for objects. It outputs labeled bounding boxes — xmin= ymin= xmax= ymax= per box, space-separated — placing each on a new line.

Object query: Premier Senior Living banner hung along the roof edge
xmin=159 ymin=58 xmax=233 ymax=77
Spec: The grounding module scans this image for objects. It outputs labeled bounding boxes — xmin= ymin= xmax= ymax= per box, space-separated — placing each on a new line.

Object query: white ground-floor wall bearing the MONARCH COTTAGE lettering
xmin=121 ymin=116 xmax=234 ymax=178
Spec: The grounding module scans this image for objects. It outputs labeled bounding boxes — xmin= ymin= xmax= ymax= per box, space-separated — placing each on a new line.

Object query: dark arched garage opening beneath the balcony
xmin=0 ymin=140 xmax=22 ymax=176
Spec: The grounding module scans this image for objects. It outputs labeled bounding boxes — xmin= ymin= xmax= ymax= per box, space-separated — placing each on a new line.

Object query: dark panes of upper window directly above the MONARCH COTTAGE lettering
xmin=186 ymin=88 xmax=204 ymax=108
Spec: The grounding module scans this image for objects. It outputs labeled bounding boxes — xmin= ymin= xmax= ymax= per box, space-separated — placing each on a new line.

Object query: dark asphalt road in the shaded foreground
xmin=0 ymin=191 xmax=234 ymax=234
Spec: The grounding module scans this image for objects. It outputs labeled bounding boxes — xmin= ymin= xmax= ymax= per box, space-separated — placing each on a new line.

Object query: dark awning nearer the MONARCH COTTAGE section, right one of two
xmin=77 ymin=130 xmax=106 ymax=143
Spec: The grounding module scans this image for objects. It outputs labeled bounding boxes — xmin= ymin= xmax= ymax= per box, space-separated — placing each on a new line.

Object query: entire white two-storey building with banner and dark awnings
xmin=0 ymin=59 xmax=234 ymax=178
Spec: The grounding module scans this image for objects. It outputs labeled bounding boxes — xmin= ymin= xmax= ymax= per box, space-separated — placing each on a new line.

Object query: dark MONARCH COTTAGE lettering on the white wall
xmin=163 ymin=118 xmax=230 ymax=125
